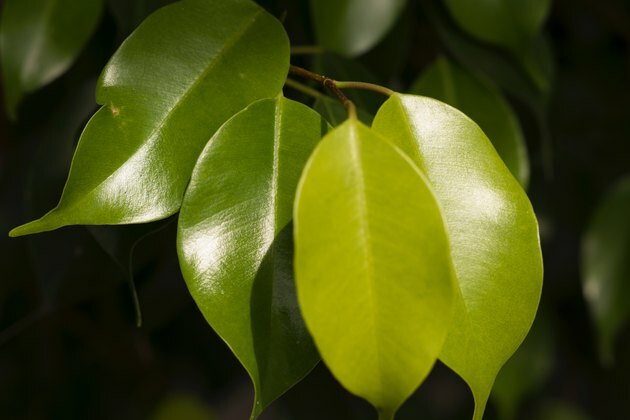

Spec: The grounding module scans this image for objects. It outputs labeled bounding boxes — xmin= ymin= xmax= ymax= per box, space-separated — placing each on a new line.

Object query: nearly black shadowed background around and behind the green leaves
xmin=0 ymin=0 xmax=630 ymax=420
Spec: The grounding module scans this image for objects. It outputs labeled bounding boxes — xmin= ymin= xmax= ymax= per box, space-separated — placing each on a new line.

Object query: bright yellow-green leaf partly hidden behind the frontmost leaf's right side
xmin=373 ymin=94 xmax=542 ymax=419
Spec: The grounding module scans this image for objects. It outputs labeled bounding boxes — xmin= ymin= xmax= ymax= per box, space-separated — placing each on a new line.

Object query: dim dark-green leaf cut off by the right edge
xmin=582 ymin=177 xmax=630 ymax=365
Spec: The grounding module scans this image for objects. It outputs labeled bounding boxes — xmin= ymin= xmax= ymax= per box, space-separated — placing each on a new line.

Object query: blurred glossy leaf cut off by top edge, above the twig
xmin=311 ymin=0 xmax=407 ymax=57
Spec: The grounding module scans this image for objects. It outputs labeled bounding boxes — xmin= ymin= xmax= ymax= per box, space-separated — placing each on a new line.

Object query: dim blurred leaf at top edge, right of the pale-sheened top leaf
xmin=445 ymin=0 xmax=551 ymax=48
